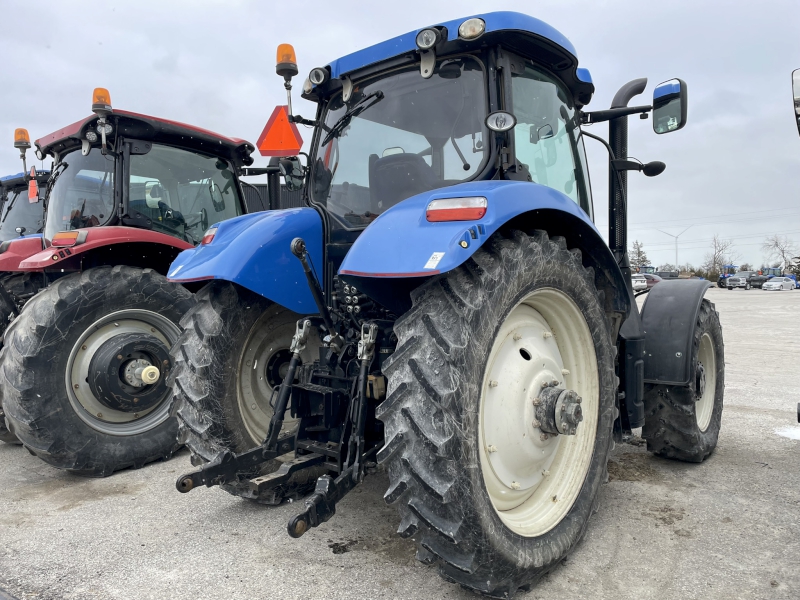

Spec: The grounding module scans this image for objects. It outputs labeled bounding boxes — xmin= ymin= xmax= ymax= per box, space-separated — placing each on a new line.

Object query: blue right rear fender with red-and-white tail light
xmin=339 ymin=181 xmax=600 ymax=277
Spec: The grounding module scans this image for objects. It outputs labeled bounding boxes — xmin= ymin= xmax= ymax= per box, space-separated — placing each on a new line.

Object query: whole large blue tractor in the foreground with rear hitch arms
xmin=168 ymin=12 xmax=724 ymax=597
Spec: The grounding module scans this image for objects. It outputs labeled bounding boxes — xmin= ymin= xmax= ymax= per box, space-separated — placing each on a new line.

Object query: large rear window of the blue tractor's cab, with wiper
xmin=311 ymin=56 xmax=489 ymax=229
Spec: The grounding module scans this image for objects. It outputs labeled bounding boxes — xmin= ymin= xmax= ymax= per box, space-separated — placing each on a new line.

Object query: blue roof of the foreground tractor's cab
xmin=328 ymin=11 xmax=594 ymax=104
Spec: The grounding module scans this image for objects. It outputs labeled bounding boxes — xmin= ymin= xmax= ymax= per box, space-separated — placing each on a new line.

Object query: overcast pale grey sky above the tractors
xmin=0 ymin=0 xmax=800 ymax=265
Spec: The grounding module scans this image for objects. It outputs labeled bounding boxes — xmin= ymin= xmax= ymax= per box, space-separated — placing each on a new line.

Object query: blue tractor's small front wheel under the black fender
xmin=642 ymin=300 xmax=725 ymax=462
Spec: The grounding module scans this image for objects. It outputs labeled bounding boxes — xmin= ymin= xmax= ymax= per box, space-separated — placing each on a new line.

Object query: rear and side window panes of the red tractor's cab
xmin=45 ymin=144 xmax=242 ymax=244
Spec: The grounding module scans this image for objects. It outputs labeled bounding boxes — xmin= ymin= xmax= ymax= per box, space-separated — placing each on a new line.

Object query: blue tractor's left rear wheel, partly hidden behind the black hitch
xmin=168 ymin=281 xmax=323 ymax=504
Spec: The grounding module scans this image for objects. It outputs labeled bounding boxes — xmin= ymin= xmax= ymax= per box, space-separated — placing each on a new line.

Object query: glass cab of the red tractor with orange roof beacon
xmin=22 ymin=88 xmax=254 ymax=270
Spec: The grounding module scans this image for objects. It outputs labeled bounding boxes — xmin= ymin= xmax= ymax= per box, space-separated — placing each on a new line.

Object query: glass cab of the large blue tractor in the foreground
xmin=296 ymin=14 xmax=594 ymax=258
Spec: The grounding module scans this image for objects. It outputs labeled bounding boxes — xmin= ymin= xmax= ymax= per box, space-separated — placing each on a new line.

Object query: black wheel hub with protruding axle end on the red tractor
xmin=88 ymin=332 xmax=170 ymax=412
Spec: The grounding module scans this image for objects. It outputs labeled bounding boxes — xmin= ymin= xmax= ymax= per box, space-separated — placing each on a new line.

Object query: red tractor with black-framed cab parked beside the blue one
xmin=0 ymin=88 xmax=254 ymax=476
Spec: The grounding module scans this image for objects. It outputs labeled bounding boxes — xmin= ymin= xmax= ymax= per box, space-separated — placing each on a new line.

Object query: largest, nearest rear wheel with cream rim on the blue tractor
xmin=377 ymin=231 xmax=616 ymax=597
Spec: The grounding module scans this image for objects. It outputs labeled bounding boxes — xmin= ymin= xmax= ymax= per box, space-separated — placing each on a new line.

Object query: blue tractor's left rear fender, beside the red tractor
xmin=167 ymin=208 xmax=322 ymax=314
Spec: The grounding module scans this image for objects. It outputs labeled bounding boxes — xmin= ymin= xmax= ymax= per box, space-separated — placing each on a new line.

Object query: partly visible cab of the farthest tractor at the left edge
xmin=0 ymin=171 xmax=50 ymax=243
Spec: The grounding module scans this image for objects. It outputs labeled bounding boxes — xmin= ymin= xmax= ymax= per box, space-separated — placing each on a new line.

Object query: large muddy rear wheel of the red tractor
xmin=0 ymin=266 xmax=194 ymax=477
